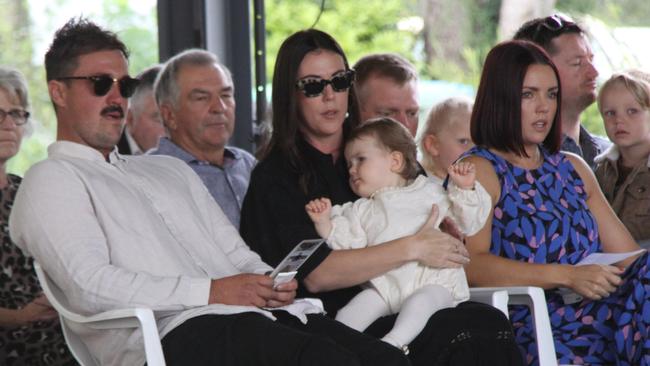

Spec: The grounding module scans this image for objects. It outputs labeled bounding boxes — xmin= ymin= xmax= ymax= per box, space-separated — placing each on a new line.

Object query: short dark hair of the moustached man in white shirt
xmin=45 ymin=17 xmax=129 ymax=81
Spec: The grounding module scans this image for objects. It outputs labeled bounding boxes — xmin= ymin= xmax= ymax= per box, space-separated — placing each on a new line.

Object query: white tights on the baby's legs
xmin=336 ymin=285 xmax=453 ymax=348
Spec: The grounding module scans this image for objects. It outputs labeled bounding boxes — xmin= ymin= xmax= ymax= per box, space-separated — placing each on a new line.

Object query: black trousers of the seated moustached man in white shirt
xmin=162 ymin=311 xmax=410 ymax=366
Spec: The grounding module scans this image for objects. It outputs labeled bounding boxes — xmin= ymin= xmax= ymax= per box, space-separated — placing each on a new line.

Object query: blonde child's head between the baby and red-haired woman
xmin=420 ymin=97 xmax=474 ymax=183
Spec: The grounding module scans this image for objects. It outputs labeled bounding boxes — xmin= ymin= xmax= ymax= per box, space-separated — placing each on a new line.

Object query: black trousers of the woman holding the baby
xmin=364 ymin=301 xmax=525 ymax=366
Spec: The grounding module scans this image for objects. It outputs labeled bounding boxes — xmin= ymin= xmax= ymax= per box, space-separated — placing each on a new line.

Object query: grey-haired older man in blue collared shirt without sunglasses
xmin=151 ymin=49 xmax=256 ymax=228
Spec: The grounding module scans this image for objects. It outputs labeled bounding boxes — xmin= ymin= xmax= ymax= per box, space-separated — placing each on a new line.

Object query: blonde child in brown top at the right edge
xmin=595 ymin=70 xmax=650 ymax=248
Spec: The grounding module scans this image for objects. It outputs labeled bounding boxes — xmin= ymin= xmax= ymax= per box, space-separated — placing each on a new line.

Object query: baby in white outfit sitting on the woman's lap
xmin=306 ymin=118 xmax=491 ymax=351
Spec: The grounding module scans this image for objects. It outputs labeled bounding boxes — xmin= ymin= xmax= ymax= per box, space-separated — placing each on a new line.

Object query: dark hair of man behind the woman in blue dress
xmin=513 ymin=14 xmax=585 ymax=55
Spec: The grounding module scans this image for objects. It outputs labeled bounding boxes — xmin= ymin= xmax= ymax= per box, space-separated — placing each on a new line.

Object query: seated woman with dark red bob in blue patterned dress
xmin=466 ymin=41 xmax=650 ymax=366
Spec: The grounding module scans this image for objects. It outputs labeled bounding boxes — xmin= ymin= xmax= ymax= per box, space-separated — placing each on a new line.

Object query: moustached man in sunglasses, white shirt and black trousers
xmin=9 ymin=19 xmax=408 ymax=366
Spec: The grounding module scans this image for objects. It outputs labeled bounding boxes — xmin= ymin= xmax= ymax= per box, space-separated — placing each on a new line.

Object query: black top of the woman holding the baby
xmin=240 ymin=140 xmax=360 ymax=315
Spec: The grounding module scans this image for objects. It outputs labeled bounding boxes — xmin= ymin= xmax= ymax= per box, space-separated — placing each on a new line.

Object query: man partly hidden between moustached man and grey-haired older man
xmin=117 ymin=65 xmax=165 ymax=155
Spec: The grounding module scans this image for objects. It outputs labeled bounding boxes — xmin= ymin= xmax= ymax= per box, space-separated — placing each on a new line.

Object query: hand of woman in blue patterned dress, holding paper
xmin=568 ymin=264 xmax=623 ymax=300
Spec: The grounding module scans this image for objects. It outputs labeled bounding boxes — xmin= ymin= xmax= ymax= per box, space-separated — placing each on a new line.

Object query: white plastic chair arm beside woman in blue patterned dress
xmin=470 ymin=286 xmax=557 ymax=366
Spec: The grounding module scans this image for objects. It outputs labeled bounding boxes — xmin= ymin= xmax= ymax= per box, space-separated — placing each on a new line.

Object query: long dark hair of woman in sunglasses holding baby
xmin=260 ymin=29 xmax=359 ymax=193
